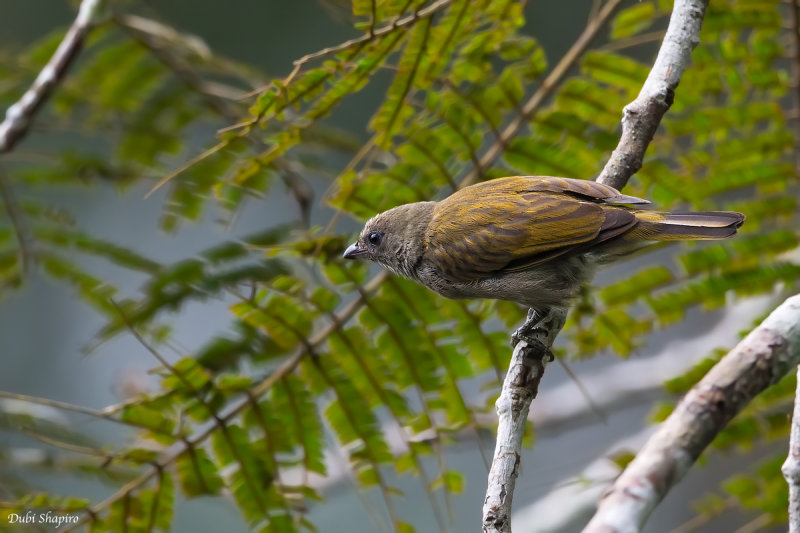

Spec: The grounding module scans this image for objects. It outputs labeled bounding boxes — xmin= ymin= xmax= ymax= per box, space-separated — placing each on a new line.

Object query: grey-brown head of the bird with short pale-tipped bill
xmin=344 ymin=202 xmax=435 ymax=279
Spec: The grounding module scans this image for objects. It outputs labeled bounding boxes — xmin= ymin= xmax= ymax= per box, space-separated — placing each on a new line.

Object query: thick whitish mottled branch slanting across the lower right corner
xmin=583 ymin=295 xmax=800 ymax=533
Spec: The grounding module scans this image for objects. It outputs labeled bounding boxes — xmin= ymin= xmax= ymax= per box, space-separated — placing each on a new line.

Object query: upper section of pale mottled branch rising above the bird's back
xmin=597 ymin=0 xmax=708 ymax=189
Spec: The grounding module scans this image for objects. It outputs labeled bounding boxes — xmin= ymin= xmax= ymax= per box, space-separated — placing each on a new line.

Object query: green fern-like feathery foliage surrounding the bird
xmin=0 ymin=0 xmax=800 ymax=532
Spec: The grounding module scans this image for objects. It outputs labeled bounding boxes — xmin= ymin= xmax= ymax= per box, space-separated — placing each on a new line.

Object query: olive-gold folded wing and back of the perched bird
xmin=425 ymin=177 xmax=643 ymax=281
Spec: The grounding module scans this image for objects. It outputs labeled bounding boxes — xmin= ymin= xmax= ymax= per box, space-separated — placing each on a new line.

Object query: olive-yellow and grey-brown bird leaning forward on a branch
xmin=344 ymin=176 xmax=745 ymax=316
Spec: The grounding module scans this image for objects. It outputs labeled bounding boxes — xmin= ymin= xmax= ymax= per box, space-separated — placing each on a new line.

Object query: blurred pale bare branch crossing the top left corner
xmin=0 ymin=0 xmax=105 ymax=154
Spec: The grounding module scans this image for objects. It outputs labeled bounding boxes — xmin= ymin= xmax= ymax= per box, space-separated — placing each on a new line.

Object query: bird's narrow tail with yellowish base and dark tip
xmin=631 ymin=211 xmax=744 ymax=241
